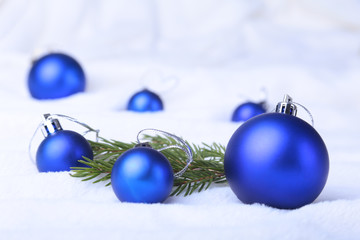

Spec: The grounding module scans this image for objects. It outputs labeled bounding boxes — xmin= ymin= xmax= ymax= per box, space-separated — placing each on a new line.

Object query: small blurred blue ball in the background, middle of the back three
xmin=127 ymin=89 xmax=164 ymax=112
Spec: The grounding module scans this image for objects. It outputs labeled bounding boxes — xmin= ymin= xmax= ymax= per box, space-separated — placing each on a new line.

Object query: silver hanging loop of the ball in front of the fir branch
xmin=136 ymin=128 xmax=193 ymax=177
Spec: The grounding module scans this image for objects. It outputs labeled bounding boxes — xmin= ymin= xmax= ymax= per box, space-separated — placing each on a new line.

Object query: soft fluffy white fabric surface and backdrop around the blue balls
xmin=0 ymin=0 xmax=360 ymax=239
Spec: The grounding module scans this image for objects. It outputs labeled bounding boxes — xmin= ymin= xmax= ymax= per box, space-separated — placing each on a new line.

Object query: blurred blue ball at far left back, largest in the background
xmin=28 ymin=53 xmax=85 ymax=99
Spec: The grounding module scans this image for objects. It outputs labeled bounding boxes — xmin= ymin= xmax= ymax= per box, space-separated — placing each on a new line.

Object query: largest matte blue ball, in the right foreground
xmin=224 ymin=113 xmax=329 ymax=209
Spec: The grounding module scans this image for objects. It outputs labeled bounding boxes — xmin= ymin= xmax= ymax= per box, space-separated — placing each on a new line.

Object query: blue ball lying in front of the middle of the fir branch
xmin=111 ymin=147 xmax=174 ymax=203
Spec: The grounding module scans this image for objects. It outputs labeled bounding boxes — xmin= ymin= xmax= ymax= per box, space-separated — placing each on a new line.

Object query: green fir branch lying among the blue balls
xmin=71 ymin=135 xmax=226 ymax=196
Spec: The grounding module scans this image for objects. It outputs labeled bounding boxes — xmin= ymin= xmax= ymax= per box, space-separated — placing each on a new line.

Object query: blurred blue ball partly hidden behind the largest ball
xmin=231 ymin=102 xmax=266 ymax=122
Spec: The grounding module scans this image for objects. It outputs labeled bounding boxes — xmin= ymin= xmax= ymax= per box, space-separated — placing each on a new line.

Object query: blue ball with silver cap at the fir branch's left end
xmin=36 ymin=130 xmax=93 ymax=172
